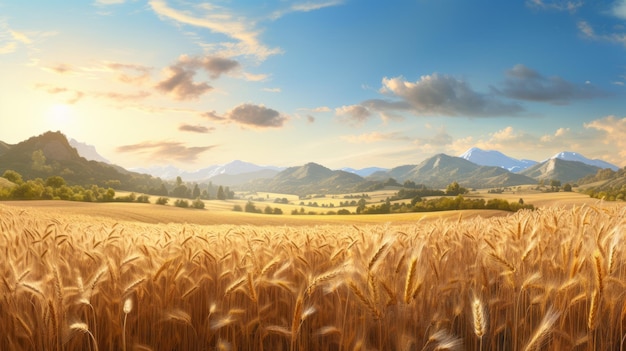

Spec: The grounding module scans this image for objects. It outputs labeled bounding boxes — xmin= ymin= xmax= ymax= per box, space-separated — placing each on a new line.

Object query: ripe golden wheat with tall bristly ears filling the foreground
xmin=0 ymin=205 xmax=626 ymax=351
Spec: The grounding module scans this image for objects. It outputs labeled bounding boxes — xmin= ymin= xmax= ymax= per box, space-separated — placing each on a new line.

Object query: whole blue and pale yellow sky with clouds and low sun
xmin=0 ymin=0 xmax=626 ymax=170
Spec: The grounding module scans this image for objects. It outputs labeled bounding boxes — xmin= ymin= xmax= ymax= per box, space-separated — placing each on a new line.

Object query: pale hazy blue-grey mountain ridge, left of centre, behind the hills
xmin=132 ymin=160 xmax=283 ymax=182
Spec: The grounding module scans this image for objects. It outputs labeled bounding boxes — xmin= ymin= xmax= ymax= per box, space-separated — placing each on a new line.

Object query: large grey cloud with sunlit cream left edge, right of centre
xmin=377 ymin=73 xmax=523 ymax=117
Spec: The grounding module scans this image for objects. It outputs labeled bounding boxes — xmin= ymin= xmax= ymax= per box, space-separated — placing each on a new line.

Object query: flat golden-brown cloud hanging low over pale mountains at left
xmin=116 ymin=141 xmax=216 ymax=162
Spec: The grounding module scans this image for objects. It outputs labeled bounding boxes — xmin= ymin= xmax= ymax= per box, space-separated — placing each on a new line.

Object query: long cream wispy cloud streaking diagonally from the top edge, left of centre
xmin=149 ymin=0 xmax=282 ymax=61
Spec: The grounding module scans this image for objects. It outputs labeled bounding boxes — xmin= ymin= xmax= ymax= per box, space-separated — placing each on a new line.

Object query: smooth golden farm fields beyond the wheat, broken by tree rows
xmin=0 ymin=191 xmax=600 ymax=226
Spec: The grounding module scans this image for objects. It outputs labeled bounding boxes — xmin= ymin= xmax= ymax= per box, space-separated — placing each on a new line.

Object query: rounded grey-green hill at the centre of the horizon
xmin=242 ymin=163 xmax=368 ymax=195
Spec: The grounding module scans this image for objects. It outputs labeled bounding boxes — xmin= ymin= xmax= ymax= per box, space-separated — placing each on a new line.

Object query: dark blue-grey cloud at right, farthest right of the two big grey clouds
xmin=496 ymin=64 xmax=606 ymax=105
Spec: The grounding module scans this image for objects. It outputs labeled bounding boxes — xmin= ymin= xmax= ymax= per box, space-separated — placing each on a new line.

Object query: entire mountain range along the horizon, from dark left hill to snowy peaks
xmin=0 ymin=132 xmax=619 ymax=195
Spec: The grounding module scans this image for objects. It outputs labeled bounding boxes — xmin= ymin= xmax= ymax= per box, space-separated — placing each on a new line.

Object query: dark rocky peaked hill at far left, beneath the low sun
xmin=0 ymin=132 xmax=161 ymax=192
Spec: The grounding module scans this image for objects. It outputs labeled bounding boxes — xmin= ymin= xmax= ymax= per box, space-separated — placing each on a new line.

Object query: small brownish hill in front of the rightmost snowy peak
xmin=520 ymin=158 xmax=600 ymax=183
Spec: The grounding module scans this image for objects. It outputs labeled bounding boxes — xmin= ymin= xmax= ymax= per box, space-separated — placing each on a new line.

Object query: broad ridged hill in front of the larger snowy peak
xmin=367 ymin=154 xmax=536 ymax=188
